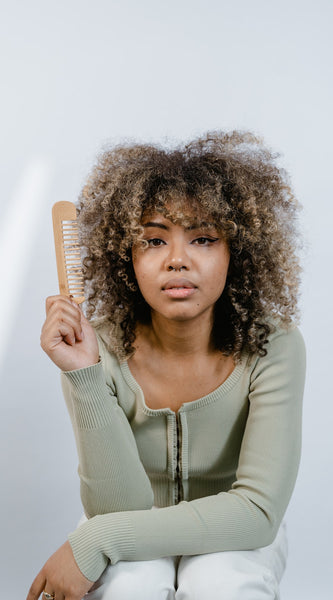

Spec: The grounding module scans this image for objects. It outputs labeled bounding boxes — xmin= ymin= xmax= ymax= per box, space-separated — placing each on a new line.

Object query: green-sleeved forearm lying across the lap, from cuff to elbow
xmin=69 ymin=493 xmax=276 ymax=580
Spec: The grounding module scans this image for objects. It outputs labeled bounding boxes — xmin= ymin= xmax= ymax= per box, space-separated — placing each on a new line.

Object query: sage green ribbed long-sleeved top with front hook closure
xmin=62 ymin=328 xmax=305 ymax=581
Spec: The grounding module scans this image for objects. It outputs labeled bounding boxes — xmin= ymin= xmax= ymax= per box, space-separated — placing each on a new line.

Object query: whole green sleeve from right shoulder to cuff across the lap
xmin=69 ymin=328 xmax=305 ymax=580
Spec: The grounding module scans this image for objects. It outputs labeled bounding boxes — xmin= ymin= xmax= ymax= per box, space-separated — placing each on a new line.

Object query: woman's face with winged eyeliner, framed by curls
xmin=132 ymin=213 xmax=230 ymax=321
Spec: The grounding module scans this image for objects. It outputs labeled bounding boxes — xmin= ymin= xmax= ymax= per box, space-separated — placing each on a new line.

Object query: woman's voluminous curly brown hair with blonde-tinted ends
xmin=78 ymin=131 xmax=300 ymax=361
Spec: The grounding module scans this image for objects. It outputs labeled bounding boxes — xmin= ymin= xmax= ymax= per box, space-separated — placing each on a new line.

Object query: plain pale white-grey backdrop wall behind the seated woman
xmin=0 ymin=0 xmax=333 ymax=600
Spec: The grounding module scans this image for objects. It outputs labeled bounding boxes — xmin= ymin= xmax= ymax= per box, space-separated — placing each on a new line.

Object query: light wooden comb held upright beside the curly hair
xmin=52 ymin=202 xmax=84 ymax=304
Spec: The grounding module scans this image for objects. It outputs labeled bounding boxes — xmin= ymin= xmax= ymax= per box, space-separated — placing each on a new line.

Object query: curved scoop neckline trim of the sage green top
xmin=120 ymin=353 xmax=247 ymax=416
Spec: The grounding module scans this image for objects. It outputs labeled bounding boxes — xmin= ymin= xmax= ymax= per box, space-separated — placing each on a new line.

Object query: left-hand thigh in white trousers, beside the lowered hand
xmin=84 ymin=556 xmax=176 ymax=600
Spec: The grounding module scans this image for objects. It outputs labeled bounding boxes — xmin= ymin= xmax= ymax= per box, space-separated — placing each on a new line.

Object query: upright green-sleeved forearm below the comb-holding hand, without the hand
xmin=62 ymin=363 xmax=153 ymax=517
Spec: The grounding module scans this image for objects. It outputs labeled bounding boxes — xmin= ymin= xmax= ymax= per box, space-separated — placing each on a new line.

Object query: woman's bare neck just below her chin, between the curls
xmin=141 ymin=311 xmax=213 ymax=358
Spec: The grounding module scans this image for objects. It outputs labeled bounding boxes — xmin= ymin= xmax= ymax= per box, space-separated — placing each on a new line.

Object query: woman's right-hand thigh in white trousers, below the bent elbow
xmin=176 ymin=522 xmax=288 ymax=600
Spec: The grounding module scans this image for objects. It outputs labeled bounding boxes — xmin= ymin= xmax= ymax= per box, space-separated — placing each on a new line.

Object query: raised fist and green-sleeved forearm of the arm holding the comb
xmin=41 ymin=296 xmax=153 ymax=516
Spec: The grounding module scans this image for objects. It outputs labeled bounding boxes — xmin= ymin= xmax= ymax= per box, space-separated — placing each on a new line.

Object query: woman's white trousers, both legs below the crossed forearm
xmin=84 ymin=522 xmax=288 ymax=600
